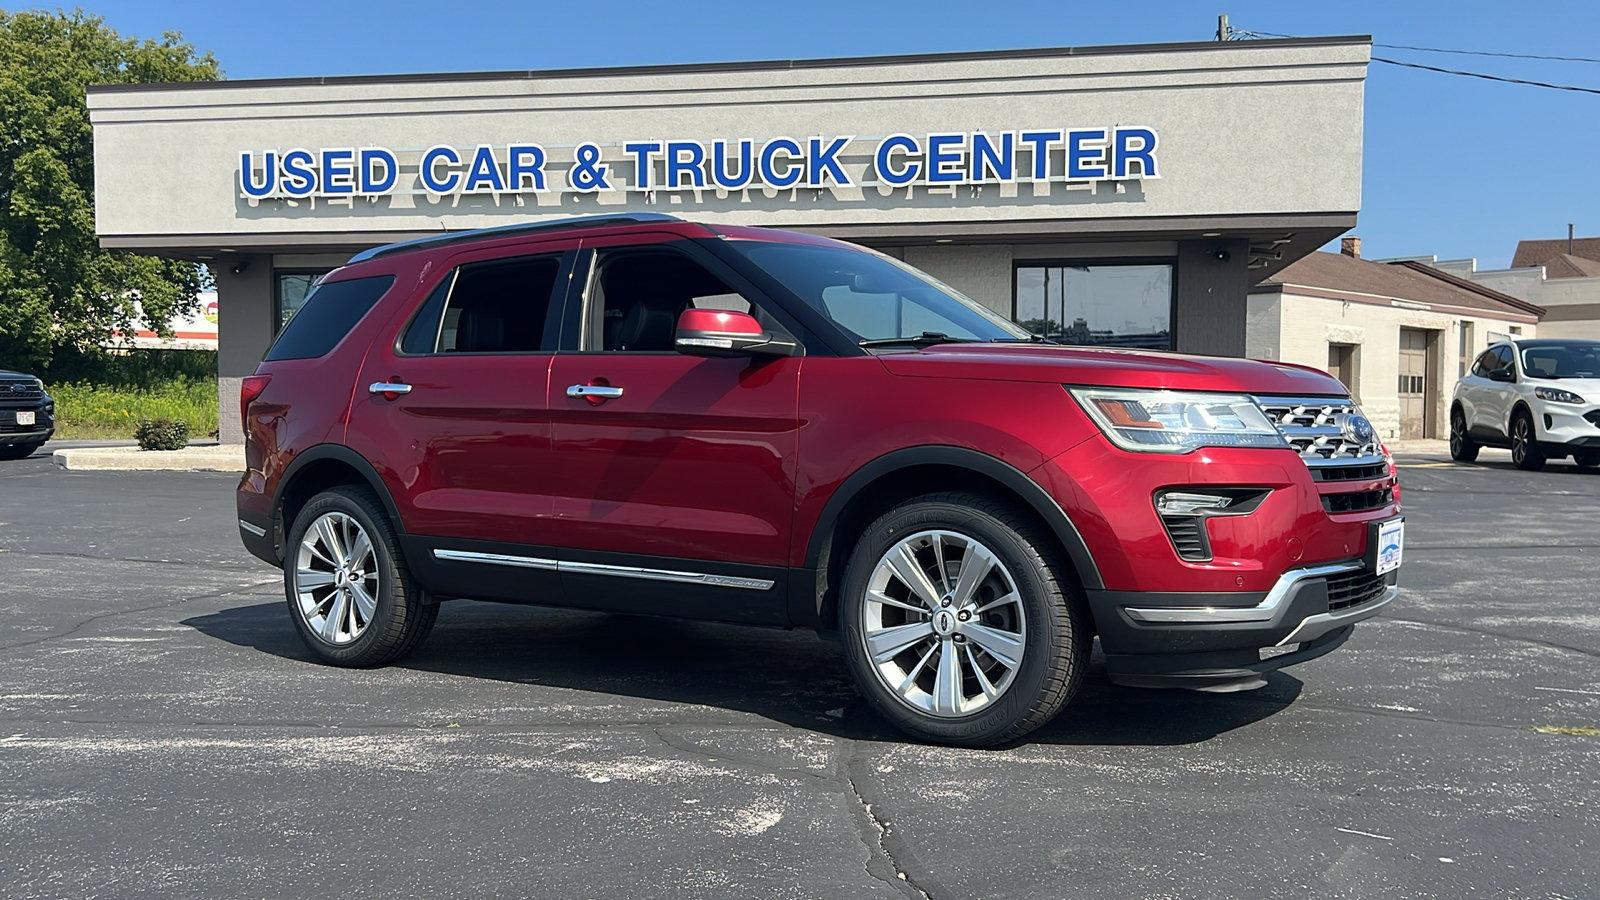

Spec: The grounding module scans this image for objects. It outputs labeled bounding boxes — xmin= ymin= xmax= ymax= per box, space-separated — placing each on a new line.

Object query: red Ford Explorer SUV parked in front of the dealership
xmin=238 ymin=215 xmax=1403 ymax=746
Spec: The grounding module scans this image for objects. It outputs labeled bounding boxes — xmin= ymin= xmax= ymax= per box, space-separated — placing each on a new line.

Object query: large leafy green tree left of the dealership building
xmin=0 ymin=10 xmax=222 ymax=368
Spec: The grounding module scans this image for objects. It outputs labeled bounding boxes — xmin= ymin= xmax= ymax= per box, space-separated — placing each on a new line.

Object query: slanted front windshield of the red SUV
xmin=730 ymin=240 xmax=1030 ymax=341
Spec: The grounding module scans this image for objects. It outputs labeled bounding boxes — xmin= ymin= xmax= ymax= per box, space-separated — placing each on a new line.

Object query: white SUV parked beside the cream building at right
xmin=1450 ymin=338 xmax=1600 ymax=471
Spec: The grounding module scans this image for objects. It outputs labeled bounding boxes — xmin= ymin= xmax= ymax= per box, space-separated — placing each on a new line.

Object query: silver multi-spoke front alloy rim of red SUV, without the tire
xmin=861 ymin=530 xmax=1027 ymax=717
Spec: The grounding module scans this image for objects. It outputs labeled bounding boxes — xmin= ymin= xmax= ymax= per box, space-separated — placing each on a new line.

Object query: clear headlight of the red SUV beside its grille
xmin=1067 ymin=388 xmax=1288 ymax=453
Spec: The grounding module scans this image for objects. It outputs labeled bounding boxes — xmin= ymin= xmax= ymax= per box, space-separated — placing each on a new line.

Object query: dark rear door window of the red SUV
xmin=400 ymin=255 xmax=562 ymax=354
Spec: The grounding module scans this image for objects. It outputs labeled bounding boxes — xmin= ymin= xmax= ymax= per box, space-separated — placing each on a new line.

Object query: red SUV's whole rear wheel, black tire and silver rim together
xmin=283 ymin=485 xmax=438 ymax=666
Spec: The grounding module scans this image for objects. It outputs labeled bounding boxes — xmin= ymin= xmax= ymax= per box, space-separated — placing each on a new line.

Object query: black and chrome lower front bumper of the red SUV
xmin=1088 ymin=559 xmax=1398 ymax=690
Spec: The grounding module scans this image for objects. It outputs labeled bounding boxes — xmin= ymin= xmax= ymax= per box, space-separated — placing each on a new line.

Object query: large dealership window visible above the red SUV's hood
xmin=1011 ymin=263 xmax=1173 ymax=351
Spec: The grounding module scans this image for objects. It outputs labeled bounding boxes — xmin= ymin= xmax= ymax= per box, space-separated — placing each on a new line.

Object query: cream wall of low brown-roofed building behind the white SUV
xmin=1248 ymin=291 xmax=1538 ymax=440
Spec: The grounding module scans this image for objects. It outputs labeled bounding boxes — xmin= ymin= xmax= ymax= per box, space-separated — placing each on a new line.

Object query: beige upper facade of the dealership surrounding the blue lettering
xmin=90 ymin=40 xmax=1370 ymax=247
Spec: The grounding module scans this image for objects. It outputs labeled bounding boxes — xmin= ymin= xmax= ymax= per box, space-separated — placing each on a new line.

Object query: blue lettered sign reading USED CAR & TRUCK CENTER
xmin=238 ymin=125 xmax=1160 ymax=199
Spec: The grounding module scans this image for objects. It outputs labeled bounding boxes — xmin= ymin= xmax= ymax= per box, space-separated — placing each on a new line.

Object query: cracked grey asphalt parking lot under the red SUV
xmin=0 ymin=441 xmax=1600 ymax=898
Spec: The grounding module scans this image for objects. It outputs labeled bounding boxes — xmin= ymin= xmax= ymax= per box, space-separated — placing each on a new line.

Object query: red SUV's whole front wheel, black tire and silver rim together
xmin=840 ymin=493 xmax=1094 ymax=746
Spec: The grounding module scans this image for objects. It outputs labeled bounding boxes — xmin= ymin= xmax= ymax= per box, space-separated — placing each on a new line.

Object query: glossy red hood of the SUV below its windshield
xmin=878 ymin=344 xmax=1349 ymax=397
